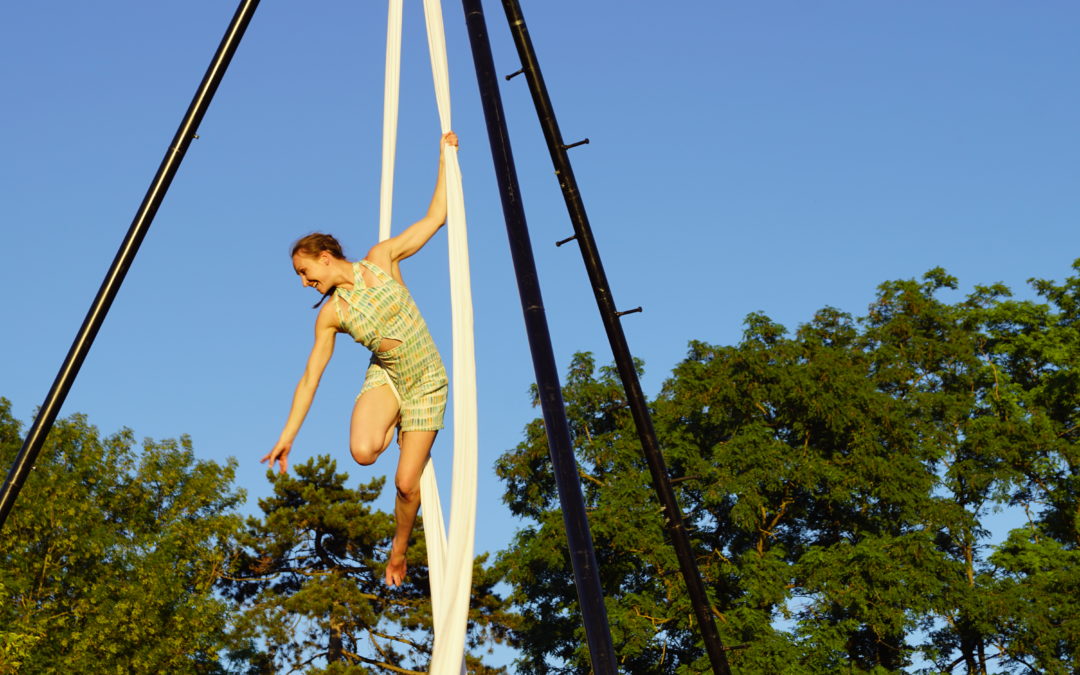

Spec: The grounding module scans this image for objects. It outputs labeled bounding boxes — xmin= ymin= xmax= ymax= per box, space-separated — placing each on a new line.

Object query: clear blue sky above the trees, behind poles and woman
xmin=0 ymin=0 xmax=1080 ymax=652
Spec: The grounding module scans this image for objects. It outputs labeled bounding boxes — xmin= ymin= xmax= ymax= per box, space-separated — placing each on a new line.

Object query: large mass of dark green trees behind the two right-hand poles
xmin=498 ymin=261 xmax=1080 ymax=674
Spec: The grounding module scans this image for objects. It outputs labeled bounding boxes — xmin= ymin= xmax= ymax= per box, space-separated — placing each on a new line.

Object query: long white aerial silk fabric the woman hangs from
xmin=379 ymin=0 xmax=477 ymax=675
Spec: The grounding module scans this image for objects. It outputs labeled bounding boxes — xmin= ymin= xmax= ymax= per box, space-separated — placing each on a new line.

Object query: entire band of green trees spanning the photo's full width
xmin=8 ymin=260 xmax=1080 ymax=675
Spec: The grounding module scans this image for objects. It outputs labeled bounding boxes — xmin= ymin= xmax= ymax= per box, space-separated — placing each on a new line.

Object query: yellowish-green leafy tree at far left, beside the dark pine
xmin=0 ymin=399 xmax=243 ymax=674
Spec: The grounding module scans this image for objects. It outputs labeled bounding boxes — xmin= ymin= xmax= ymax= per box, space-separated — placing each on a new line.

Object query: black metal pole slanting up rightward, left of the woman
xmin=0 ymin=0 xmax=259 ymax=529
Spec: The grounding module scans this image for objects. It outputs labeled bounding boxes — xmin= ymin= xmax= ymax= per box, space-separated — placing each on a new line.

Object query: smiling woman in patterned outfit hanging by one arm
xmin=261 ymin=132 xmax=458 ymax=586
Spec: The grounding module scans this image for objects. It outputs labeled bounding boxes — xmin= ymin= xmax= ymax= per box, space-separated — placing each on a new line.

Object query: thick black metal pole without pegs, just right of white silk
xmin=461 ymin=0 xmax=616 ymax=674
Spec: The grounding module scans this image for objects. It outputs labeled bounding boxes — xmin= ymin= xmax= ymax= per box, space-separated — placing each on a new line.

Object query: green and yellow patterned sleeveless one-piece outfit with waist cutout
xmin=335 ymin=260 xmax=447 ymax=431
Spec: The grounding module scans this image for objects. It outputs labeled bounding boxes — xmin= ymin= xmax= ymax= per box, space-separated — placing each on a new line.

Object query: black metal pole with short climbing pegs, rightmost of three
xmin=502 ymin=0 xmax=731 ymax=675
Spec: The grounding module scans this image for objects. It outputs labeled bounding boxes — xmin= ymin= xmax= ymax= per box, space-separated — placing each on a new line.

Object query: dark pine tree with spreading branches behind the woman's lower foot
xmin=221 ymin=456 xmax=513 ymax=675
